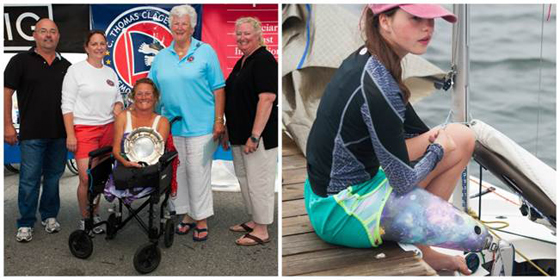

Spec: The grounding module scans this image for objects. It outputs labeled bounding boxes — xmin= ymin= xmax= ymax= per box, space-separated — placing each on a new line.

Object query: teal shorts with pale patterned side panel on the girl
xmin=304 ymin=169 xmax=393 ymax=248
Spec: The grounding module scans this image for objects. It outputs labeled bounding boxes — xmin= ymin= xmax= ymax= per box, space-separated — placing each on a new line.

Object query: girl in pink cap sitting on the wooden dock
xmin=304 ymin=4 xmax=492 ymax=274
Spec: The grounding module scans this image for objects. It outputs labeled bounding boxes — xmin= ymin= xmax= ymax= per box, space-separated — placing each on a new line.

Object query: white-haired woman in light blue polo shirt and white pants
xmin=149 ymin=5 xmax=225 ymax=241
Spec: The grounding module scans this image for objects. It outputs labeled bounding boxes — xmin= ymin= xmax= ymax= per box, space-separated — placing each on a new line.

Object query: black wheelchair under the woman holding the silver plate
xmin=68 ymin=144 xmax=177 ymax=274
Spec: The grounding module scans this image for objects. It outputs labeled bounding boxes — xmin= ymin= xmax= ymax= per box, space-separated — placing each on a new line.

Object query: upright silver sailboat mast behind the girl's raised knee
xmin=451 ymin=4 xmax=470 ymax=211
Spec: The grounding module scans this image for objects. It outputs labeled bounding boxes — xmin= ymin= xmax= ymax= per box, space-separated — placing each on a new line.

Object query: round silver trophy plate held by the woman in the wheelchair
xmin=124 ymin=127 xmax=165 ymax=165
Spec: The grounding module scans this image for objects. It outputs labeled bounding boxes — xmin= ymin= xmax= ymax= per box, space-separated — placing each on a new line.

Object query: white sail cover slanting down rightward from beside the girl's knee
xmin=471 ymin=120 xmax=556 ymax=204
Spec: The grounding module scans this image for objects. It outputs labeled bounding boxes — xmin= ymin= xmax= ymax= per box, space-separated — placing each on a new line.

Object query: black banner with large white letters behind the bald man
xmin=4 ymin=4 xmax=89 ymax=53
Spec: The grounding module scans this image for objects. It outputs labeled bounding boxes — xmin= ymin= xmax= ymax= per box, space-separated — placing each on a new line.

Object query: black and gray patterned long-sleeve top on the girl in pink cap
xmin=307 ymin=48 xmax=443 ymax=196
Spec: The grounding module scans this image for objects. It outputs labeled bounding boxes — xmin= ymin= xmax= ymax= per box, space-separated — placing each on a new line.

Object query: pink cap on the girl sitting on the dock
xmin=368 ymin=4 xmax=457 ymax=23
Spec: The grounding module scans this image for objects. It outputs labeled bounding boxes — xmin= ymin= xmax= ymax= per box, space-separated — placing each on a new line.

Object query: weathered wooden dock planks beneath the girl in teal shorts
xmin=282 ymin=133 xmax=436 ymax=276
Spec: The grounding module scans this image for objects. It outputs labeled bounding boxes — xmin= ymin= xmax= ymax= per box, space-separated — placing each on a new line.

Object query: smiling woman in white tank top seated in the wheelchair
xmin=105 ymin=78 xmax=169 ymax=203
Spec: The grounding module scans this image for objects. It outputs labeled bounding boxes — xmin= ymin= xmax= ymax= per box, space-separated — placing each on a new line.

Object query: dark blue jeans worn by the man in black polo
xmin=17 ymin=138 xmax=67 ymax=228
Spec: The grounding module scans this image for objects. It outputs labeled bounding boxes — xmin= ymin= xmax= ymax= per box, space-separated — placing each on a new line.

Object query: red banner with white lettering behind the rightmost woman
xmin=202 ymin=4 xmax=278 ymax=78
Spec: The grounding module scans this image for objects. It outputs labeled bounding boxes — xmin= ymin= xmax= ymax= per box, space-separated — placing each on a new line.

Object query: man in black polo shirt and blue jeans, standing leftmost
xmin=4 ymin=19 xmax=70 ymax=242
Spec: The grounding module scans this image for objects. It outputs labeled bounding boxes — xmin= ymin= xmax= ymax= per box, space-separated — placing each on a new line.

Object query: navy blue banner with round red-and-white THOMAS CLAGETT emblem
xmin=91 ymin=4 xmax=202 ymax=94
